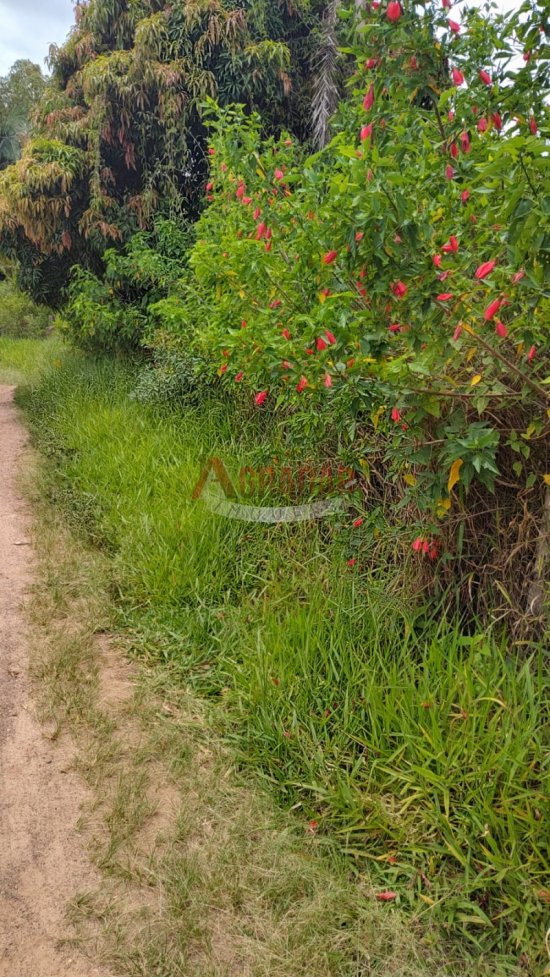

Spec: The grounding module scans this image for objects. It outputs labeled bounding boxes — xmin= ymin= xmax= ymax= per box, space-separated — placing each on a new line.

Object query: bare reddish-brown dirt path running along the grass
xmin=0 ymin=385 xmax=103 ymax=977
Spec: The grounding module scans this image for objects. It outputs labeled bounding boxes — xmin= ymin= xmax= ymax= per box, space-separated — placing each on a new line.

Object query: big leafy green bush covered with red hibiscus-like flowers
xmin=61 ymin=4 xmax=550 ymax=613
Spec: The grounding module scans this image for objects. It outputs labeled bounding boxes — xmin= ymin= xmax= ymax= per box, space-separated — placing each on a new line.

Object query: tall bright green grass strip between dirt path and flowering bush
xmin=12 ymin=346 xmax=548 ymax=975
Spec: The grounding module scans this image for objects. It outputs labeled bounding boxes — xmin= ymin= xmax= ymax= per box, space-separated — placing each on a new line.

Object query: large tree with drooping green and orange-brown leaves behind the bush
xmin=0 ymin=0 xmax=338 ymax=304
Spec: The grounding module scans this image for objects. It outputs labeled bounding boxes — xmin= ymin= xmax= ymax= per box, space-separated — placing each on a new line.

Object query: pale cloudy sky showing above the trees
xmin=0 ymin=0 xmax=520 ymax=75
